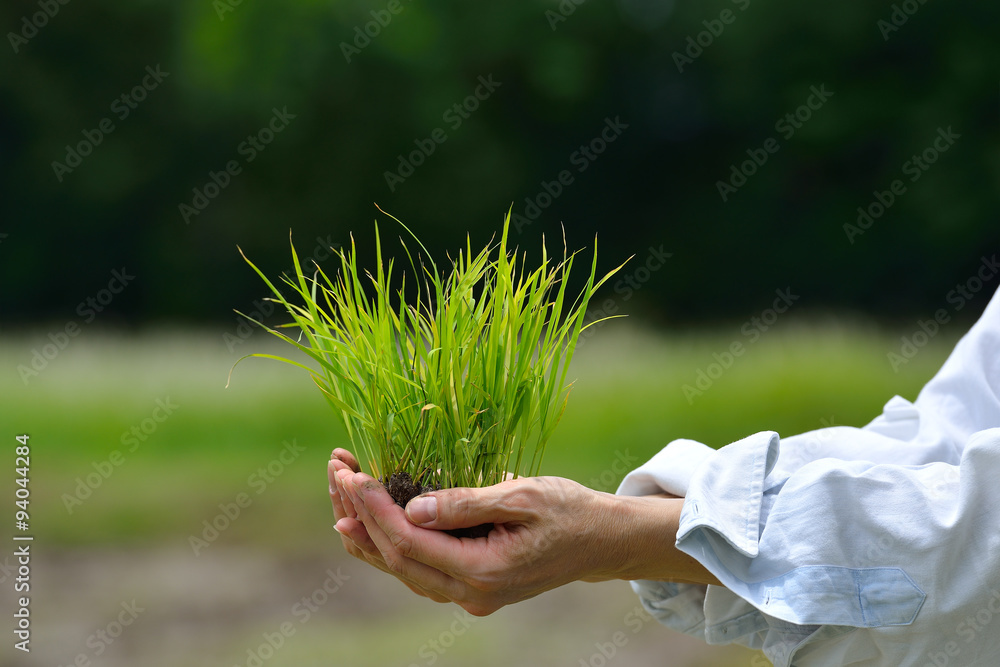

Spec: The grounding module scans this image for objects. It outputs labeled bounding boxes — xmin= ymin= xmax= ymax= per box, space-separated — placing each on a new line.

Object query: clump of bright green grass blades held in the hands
xmin=234 ymin=212 xmax=624 ymax=496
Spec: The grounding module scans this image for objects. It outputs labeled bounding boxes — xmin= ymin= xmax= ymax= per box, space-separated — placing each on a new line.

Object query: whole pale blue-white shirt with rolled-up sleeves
xmin=618 ymin=284 xmax=1000 ymax=667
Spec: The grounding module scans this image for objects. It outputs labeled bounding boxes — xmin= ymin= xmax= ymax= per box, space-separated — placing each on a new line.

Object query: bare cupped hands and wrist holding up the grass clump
xmin=328 ymin=454 xmax=718 ymax=615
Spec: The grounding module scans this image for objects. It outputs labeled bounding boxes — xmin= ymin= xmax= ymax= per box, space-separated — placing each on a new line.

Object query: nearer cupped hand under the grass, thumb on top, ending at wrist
xmin=347 ymin=474 xmax=614 ymax=615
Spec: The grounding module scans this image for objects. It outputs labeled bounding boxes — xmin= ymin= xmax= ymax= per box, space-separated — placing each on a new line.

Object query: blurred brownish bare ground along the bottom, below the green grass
xmin=0 ymin=545 xmax=769 ymax=667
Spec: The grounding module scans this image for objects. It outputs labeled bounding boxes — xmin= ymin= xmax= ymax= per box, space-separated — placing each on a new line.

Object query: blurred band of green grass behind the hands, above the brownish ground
xmin=0 ymin=322 xmax=954 ymax=545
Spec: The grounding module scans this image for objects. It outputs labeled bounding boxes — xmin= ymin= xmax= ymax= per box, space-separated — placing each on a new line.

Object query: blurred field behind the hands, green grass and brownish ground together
xmin=0 ymin=319 xmax=961 ymax=666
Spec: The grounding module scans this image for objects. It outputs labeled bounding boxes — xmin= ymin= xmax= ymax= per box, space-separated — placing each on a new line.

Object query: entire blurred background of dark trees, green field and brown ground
xmin=0 ymin=0 xmax=1000 ymax=667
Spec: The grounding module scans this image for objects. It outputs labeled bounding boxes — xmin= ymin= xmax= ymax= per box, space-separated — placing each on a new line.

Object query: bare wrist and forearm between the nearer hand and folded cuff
xmin=584 ymin=494 xmax=721 ymax=585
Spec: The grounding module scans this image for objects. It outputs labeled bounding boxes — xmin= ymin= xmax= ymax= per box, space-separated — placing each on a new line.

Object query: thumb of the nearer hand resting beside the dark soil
xmin=406 ymin=482 xmax=526 ymax=530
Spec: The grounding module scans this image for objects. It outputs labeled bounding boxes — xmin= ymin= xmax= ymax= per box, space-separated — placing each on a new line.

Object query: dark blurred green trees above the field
xmin=0 ymin=0 xmax=1000 ymax=326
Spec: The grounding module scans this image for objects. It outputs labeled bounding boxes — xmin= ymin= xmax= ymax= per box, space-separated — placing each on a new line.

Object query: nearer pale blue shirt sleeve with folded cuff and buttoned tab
xmin=637 ymin=428 xmax=1000 ymax=667
